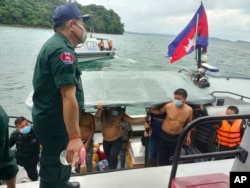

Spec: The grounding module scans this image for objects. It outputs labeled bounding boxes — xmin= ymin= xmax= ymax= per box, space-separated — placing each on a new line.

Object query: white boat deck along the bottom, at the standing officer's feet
xmin=0 ymin=159 xmax=234 ymax=188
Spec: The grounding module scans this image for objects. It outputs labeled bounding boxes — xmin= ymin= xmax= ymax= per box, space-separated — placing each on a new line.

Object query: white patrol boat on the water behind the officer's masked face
xmin=75 ymin=37 xmax=116 ymax=63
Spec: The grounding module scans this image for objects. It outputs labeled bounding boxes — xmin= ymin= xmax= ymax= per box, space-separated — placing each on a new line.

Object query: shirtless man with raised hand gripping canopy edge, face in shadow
xmin=95 ymin=103 xmax=146 ymax=169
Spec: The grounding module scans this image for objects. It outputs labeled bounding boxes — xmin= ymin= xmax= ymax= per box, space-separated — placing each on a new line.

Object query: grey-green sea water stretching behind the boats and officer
xmin=0 ymin=26 xmax=250 ymax=128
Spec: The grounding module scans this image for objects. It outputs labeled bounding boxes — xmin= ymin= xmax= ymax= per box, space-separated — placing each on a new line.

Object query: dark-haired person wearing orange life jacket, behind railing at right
xmin=217 ymin=106 xmax=245 ymax=156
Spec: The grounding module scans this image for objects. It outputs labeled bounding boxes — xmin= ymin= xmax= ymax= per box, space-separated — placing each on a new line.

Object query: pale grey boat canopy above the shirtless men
xmin=82 ymin=71 xmax=215 ymax=108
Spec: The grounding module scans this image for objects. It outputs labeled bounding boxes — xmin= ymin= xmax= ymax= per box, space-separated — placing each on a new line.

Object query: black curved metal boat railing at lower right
xmin=168 ymin=114 xmax=250 ymax=188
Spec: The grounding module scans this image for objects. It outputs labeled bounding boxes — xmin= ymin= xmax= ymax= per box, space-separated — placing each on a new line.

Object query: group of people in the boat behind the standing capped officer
xmin=0 ymin=89 xmax=246 ymax=186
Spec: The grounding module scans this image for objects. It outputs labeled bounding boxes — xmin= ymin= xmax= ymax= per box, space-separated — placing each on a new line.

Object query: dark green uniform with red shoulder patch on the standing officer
xmin=32 ymin=33 xmax=84 ymax=188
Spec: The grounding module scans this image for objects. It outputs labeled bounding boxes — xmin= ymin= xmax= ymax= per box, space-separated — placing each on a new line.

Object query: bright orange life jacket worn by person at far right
xmin=217 ymin=119 xmax=242 ymax=147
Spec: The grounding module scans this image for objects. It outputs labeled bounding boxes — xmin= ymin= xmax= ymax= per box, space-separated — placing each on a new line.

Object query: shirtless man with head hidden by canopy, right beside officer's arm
xmin=79 ymin=111 xmax=95 ymax=172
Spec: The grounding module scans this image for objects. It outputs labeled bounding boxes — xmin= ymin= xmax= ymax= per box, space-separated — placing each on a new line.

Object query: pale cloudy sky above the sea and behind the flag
xmin=77 ymin=0 xmax=250 ymax=42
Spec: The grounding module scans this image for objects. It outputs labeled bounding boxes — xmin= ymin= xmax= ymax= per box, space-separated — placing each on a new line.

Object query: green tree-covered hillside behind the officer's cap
xmin=0 ymin=0 xmax=124 ymax=34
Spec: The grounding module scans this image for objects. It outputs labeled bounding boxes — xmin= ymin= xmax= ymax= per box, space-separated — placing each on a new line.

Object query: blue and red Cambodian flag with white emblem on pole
xmin=168 ymin=2 xmax=208 ymax=63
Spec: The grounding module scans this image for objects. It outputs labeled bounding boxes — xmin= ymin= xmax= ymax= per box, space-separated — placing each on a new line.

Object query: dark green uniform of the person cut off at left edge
xmin=0 ymin=106 xmax=18 ymax=180
